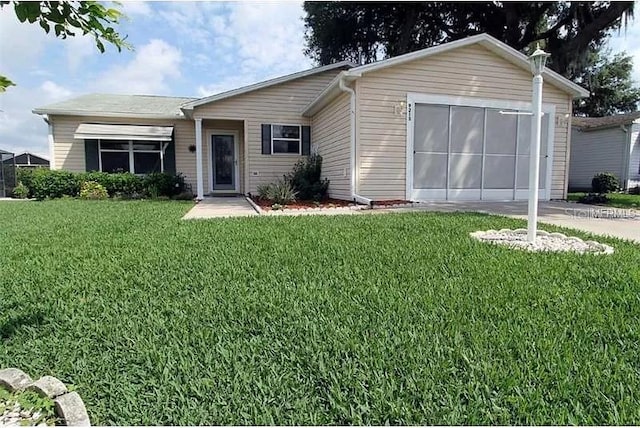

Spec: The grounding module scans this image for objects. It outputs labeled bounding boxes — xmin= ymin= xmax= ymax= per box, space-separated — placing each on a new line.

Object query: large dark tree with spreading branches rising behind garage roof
xmin=304 ymin=1 xmax=633 ymax=77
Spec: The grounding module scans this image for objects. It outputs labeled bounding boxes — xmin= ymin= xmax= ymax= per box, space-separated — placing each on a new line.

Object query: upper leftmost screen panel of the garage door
xmin=413 ymin=104 xmax=449 ymax=153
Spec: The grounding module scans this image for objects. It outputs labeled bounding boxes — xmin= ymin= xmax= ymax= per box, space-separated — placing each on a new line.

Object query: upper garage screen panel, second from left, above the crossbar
xmin=451 ymin=106 xmax=484 ymax=153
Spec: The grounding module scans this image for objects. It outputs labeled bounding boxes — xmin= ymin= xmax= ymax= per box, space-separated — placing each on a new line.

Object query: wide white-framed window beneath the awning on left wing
xmin=99 ymin=140 xmax=168 ymax=174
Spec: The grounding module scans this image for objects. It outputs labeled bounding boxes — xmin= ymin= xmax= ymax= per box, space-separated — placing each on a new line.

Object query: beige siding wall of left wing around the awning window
xmin=50 ymin=116 xmax=196 ymax=190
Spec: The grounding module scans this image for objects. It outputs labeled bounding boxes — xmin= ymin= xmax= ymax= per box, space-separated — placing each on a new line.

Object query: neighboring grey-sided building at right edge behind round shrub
xmin=569 ymin=112 xmax=640 ymax=191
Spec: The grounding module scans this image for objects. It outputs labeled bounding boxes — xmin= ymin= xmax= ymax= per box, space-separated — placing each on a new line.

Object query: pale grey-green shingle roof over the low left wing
xmin=33 ymin=94 xmax=195 ymax=119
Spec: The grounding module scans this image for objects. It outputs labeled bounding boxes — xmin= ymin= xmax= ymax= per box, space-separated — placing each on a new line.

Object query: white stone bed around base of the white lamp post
xmin=470 ymin=229 xmax=613 ymax=254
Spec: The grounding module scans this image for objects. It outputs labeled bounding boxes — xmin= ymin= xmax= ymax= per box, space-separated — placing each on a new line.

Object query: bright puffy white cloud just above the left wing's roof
xmin=89 ymin=39 xmax=182 ymax=95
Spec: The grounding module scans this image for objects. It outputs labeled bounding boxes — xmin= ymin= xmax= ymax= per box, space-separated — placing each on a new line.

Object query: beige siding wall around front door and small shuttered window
xmin=193 ymin=70 xmax=340 ymax=193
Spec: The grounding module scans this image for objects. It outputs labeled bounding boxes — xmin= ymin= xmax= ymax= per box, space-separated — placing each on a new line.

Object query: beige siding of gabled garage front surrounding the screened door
xmin=356 ymin=45 xmax=572 ymax=200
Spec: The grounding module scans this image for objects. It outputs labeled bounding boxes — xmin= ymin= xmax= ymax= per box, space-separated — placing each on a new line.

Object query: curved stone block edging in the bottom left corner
xmin=0 ymin=368 xmax=91 ymax=426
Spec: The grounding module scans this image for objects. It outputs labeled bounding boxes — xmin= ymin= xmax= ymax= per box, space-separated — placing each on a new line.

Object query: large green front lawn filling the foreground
xmin=0 ymin=200 xmax=640 ymax=425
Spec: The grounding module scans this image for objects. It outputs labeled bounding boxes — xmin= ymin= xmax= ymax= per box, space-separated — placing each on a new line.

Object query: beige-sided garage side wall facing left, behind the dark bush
xmin=311 ymin=93 xmax=351 ymax=199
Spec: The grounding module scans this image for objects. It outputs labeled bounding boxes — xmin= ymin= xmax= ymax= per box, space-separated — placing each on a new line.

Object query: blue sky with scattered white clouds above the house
xmin=0 ymin=2 xmax=640 ymax=156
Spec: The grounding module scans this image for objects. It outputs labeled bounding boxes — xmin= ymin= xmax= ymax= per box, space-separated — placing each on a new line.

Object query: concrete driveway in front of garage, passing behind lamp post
xmin=400 ymin=201 xmax=640 ymax=243
